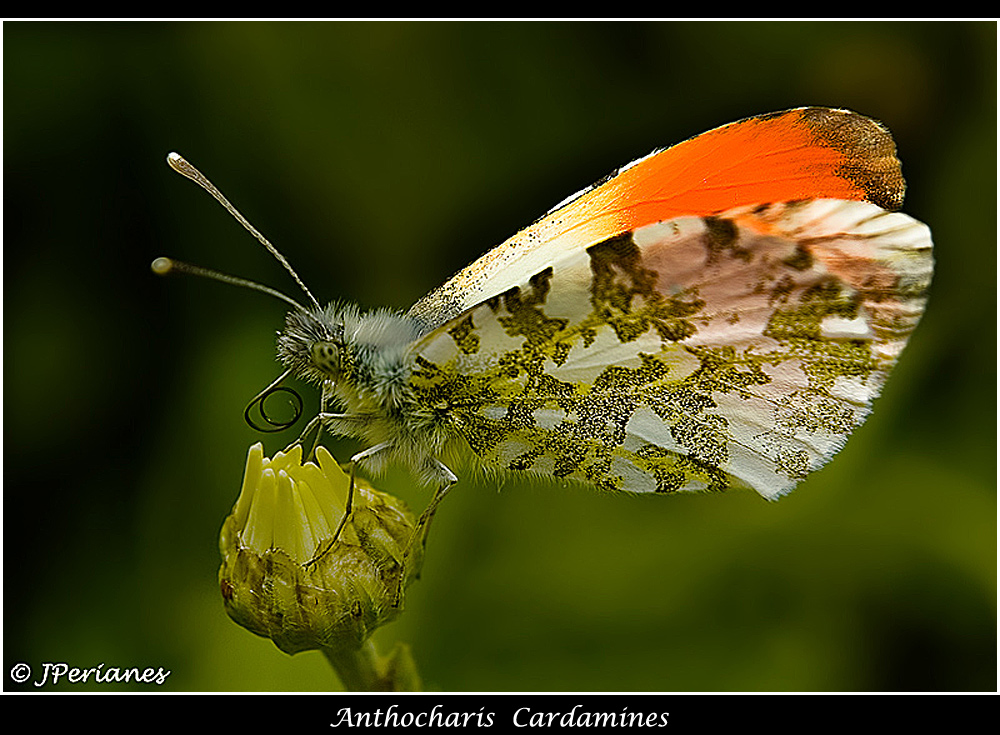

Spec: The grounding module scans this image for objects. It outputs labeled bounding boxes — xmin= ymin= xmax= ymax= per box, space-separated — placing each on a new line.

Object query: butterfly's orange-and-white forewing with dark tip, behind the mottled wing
xmin=410 ymin=107 xmax=905 ymax=325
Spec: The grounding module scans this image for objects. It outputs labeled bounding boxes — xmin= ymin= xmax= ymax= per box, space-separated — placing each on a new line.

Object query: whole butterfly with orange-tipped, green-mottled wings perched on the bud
xmin=154 ymin=107 xmax=933 ymax=516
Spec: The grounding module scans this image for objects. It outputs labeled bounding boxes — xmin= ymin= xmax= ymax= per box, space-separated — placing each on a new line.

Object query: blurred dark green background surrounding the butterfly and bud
xmin=3 ymin=21 xmax=997 ymax=691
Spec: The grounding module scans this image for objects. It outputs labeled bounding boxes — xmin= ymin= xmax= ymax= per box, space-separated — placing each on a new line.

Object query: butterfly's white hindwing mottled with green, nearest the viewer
xmin=409 ymin=200 xmax=932 ymax=498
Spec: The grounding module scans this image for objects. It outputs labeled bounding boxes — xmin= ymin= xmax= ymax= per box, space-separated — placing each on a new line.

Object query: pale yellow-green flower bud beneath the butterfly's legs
xmin=219 ymin=443 xmax=423 ymax=653
